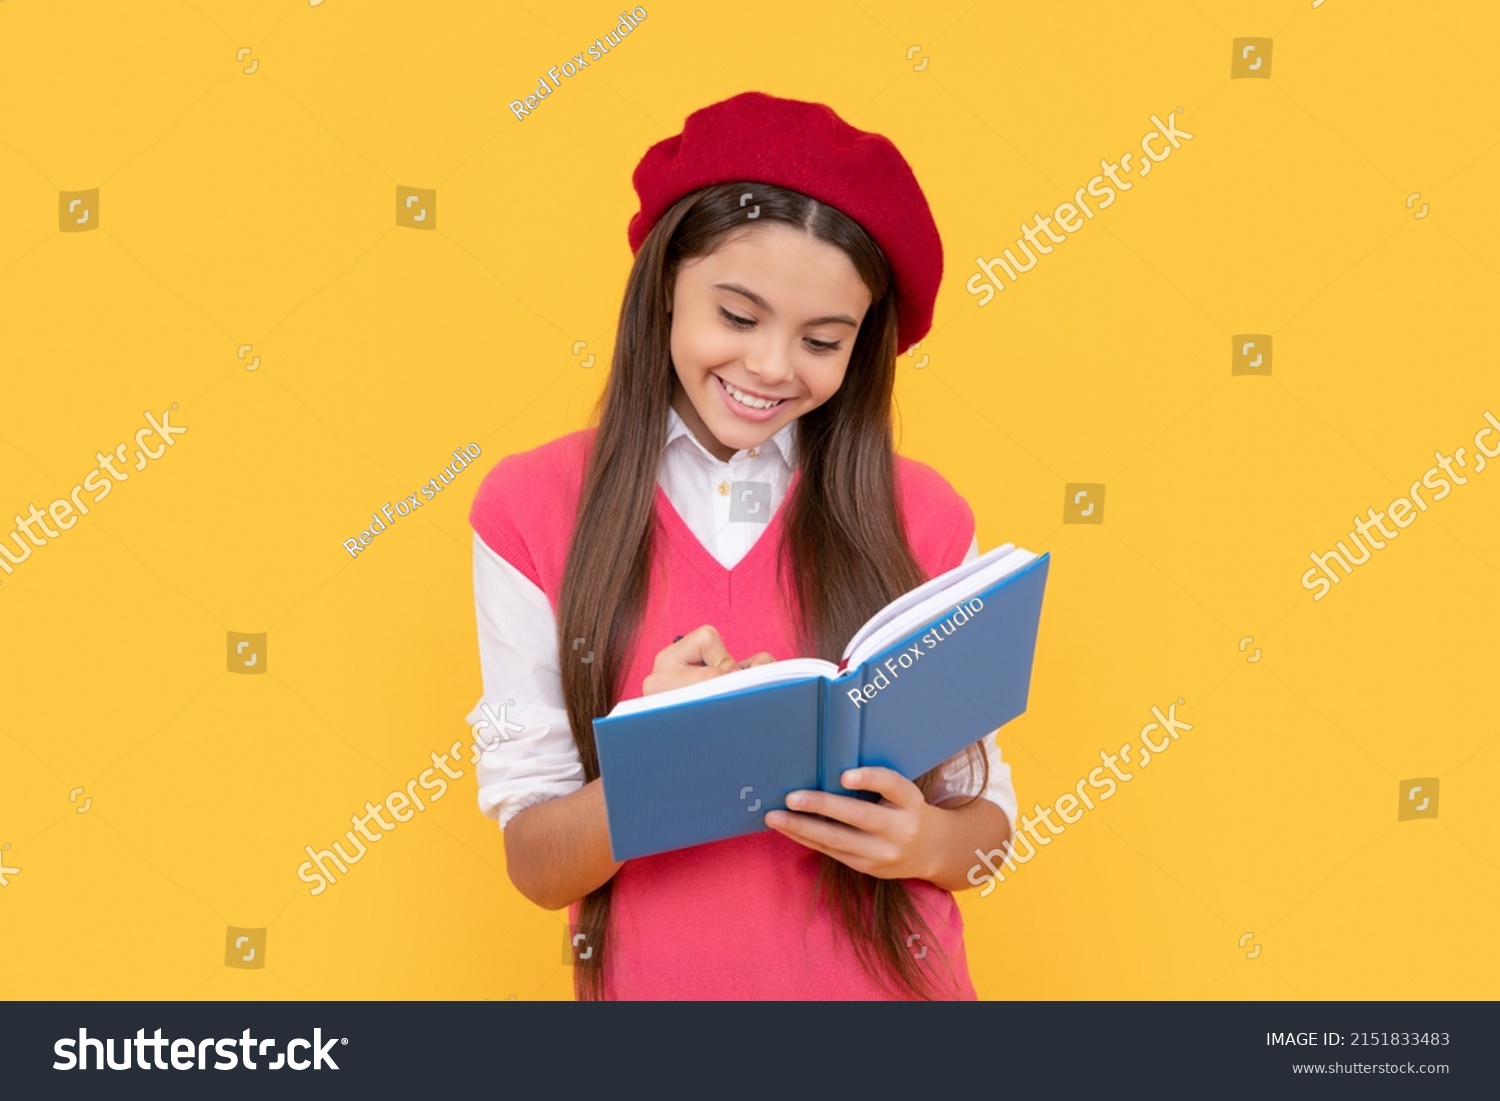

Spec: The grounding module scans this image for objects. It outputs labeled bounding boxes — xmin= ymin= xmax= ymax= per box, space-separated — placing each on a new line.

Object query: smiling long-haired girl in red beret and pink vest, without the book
xmin=470 ymin=93 xmax=1016 ymax=999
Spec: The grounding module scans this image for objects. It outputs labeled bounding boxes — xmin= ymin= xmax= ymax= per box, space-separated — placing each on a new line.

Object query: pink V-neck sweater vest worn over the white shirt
xmin=470 ymin=429 xmax=975 ymax=1001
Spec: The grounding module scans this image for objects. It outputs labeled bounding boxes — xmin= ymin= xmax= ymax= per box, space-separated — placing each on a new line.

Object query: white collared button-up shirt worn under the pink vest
xmin=467 ymin=410 xmax=1016 ymax=830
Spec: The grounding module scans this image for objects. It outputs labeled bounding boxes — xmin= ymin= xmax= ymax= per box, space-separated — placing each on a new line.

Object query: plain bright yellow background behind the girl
xmin=0 ymin=0 xmax=1500 ymax=999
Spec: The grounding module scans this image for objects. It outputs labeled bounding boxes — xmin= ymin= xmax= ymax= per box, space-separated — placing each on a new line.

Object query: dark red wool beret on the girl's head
xmin=630 ymin=92 xmax=942 ymax=350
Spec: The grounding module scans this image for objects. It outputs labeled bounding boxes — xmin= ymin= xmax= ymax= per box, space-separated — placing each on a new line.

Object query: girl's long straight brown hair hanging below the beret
xmin=557 ymin=182 xmax=989 ymax=999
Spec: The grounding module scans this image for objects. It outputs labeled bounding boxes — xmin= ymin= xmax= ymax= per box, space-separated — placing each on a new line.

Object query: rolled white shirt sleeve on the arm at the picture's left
xmin=467 ymin=534 xmax=584 ymax=830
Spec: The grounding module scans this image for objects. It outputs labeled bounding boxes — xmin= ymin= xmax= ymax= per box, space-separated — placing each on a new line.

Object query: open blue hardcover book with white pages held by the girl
xmin=594 ymin=543 xmax=1052 ymax=861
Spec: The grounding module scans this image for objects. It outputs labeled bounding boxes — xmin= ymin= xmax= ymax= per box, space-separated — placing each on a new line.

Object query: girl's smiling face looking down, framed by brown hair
xmin=672 ymin=222 xmax=870 ymax=461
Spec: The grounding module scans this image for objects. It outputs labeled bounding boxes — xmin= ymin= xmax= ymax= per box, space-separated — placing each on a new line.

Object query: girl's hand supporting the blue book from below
xmin=765 ymin=765 xmax=942 ymax=879
